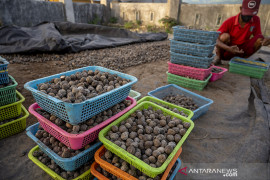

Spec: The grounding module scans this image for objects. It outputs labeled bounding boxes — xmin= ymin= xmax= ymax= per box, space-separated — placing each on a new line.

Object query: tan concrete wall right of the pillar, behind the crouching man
xmin=180 ymin=4 xmax=270 ymax=35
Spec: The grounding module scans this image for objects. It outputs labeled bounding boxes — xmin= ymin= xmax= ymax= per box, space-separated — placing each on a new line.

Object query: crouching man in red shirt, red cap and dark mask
xmin=214 ymin=0 xmax=270 ymax=64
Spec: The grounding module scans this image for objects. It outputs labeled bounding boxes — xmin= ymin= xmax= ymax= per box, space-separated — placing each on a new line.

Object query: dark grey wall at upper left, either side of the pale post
xmin=0 ymin=0 xmax=105 ymax=26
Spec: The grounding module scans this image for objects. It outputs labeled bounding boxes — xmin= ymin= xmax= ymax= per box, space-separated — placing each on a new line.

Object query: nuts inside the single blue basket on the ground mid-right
xmin=162 ymin=94 xmax=199 ymax=111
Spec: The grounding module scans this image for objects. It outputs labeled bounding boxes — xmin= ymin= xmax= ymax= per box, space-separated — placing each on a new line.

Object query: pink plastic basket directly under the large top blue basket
xmin=29 ymin=97 xmax=137 ymax=150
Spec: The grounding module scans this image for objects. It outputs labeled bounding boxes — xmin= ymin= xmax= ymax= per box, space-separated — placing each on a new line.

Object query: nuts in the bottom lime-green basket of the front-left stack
xmin=33 ymin=150 xmax=91 ymax=179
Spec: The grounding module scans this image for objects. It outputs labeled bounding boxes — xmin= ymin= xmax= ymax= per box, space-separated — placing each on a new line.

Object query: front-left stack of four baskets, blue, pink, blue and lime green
xmin=24 ymin=66 xmax=137 ymax=179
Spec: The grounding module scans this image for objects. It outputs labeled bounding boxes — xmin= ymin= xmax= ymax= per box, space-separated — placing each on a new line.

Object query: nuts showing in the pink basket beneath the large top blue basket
xmin=35 ymin=100 xmax=131 ymax=134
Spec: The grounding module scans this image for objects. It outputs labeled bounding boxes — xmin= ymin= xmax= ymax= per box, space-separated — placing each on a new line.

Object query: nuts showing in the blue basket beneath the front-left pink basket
xmin=35 ymin=127 xmax=96 ymax=158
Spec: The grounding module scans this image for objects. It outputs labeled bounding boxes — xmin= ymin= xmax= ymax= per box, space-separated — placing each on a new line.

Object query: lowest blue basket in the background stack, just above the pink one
xmin=171 ymin=52 xmax=215 ymax=69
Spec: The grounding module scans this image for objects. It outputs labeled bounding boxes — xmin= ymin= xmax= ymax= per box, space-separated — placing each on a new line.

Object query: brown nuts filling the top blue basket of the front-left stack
xmin=38 ymin=70 xmax=130 ymax=103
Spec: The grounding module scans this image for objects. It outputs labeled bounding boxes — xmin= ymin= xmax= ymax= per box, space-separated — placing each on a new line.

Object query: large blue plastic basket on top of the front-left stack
xmin=24 ymin=66 xmax=137 ymax=125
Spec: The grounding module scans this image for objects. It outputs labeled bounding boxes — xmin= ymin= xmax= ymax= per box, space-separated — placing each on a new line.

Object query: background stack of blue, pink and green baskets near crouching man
xmin=167 ymin=26 xmax=219 ymax=90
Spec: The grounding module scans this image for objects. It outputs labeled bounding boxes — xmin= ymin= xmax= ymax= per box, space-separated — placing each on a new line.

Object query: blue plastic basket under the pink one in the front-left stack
xmin=26 ymin=123 xmax=102 ymax=171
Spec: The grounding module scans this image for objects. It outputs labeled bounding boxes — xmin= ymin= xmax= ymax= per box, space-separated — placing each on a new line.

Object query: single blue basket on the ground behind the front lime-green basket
xmin=148 ymin=84 xmax=213 ymax=120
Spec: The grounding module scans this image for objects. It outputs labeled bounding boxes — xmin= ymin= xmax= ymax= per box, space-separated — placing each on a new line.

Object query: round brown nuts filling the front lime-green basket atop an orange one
xmin=106 ymin=107 xmax=190 ymax=168
